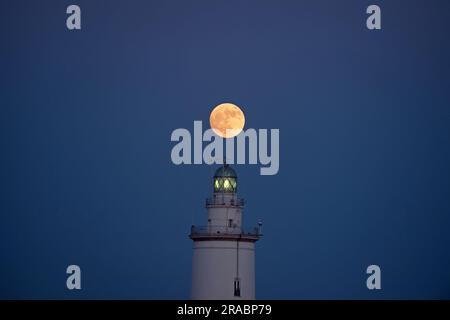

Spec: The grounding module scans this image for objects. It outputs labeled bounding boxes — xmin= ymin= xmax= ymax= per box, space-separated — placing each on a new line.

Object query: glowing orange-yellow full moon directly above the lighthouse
xmin=209 ymin=103 xmax=245 ymax=138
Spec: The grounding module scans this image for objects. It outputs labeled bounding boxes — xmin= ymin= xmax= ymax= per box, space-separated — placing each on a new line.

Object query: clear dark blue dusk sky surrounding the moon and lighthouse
xmin=0 ymin=0 xmax=450 ymax=299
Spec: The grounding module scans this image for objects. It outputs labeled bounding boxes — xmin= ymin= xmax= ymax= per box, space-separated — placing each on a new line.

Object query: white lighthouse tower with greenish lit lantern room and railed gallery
xmin=189 ymin=163 xmax=261 ymax=300
